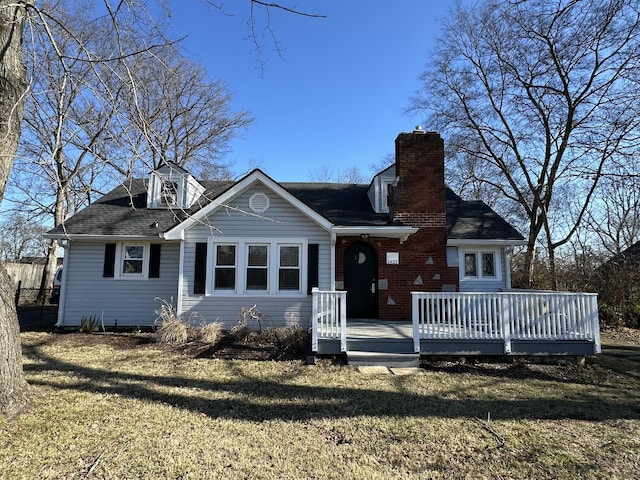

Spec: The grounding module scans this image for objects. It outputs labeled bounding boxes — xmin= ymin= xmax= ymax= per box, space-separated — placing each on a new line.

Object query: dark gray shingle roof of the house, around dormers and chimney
xmin=49 ymin=179 xmax=523 ymax=240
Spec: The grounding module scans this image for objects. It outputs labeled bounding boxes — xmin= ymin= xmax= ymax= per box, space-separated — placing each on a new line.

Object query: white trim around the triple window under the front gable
xmin=206 ymin=237 xmax=308 ymax=297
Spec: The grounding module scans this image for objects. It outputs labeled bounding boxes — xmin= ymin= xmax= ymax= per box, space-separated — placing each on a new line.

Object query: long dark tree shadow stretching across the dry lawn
xmin=23 ymin=345 xmax=640 ymax=421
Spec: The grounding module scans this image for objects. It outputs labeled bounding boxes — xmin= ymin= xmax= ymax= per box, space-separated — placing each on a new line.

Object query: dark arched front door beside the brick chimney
xmin=344 ymin=242 xmax=378 ymax=318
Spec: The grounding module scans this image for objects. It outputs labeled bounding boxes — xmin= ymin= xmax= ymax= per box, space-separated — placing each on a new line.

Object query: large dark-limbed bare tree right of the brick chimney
xmin=415 ymin=0 xmax=640 ymax=282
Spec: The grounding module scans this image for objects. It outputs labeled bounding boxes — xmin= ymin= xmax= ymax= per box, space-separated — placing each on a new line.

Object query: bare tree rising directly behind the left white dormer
xmin=105 ymin=46 xmax=252 ymax=179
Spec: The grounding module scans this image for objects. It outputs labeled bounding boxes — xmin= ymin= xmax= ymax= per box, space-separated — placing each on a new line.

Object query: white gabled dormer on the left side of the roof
xmin=147 ymin=162 xmax=204 ymax=210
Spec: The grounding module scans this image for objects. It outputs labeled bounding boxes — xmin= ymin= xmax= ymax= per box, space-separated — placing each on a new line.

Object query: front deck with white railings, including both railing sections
xmin=312 ymin=291 xmax=600 ymax=356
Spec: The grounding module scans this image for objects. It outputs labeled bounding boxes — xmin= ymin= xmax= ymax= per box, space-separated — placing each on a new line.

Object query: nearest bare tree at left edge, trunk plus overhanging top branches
xmin=0 ymin=0 xmax=320 ymax=417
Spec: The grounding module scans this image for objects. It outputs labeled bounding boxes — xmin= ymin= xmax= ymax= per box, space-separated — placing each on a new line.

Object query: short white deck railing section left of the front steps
xmin=311 ymin=288 xmax=347 ymax=352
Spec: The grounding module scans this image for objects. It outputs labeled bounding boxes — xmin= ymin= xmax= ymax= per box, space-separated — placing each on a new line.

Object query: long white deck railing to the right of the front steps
xmin=412 ymin=291 xmax=600 ymax=353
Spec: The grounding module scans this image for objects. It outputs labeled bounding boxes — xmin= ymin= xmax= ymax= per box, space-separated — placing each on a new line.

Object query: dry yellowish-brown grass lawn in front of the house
xmin=0 ymin=333 xmax=640 ymax=480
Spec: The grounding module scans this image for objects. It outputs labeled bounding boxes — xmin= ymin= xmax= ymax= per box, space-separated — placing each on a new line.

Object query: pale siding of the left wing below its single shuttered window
xmin=59 ymin=241 xmax=180 ymax=327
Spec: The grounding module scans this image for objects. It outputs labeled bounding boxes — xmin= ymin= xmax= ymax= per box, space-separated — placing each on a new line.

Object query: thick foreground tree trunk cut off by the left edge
xmin=0 ymin=0 xmax=30 ymax=417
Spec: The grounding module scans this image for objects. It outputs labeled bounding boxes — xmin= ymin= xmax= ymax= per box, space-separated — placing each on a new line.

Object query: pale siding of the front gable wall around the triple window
xmin=181 ymin=185 xmax=331 ymax=328
